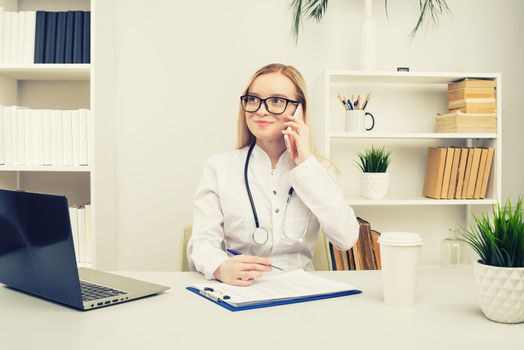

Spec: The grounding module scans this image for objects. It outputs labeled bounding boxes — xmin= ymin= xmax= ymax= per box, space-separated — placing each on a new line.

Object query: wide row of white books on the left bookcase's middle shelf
xmin=0 ymin=106 xmax=90 ymax=166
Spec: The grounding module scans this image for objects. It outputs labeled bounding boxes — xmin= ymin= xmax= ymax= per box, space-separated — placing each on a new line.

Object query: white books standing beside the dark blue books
xmin=0 ymin=7 xmax=36 ymax=64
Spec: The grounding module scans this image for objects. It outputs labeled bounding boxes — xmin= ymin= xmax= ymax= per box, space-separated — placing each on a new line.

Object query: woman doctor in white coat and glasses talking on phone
xmin=187 ymin=64 xmax=359 ymax=286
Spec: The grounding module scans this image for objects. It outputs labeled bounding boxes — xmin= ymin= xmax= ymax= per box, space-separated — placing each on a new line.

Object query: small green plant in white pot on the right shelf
xmin=357 ymin=146 xmax=391 ymax=199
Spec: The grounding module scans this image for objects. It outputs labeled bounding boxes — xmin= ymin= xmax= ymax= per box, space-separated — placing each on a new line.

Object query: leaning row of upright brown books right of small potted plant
xmin=423 ymin=147 xmax=494 ymax=199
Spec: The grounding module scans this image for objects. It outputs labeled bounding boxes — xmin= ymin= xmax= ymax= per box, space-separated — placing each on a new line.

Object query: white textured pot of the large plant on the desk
xmin=475 ymin=262 xmax=524 ymax=323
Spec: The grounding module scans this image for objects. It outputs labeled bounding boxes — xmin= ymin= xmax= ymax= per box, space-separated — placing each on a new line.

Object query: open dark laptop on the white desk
xmin=0 ymin=190 xmax=169 ymax=310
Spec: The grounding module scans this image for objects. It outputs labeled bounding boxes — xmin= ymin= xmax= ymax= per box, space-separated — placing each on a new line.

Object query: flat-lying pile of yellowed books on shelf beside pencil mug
xmin=435 ymin=78 xmax=497 ymax=133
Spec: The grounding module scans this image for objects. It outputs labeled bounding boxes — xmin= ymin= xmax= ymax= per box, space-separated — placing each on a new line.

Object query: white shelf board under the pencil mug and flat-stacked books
xmin=329 ymin=132 xmax=497 ymax=139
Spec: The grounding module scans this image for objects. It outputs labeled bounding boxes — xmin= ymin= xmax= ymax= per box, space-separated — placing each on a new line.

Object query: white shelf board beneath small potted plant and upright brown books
xmin=347 ymin=197 xmax=497 ymax=206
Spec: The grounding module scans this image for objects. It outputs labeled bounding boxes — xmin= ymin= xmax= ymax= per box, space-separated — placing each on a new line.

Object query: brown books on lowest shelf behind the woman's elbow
xmin=328 ymin=218 xmax=382 ymax=271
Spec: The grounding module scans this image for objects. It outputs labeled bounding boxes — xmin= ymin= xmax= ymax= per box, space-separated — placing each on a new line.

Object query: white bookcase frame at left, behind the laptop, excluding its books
xmin=0 ymin=0 xmax=107 ymax=266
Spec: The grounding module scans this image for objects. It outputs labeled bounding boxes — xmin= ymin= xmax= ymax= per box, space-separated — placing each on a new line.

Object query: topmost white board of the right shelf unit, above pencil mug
xmin=325 ymin=71 xmax=499 ymax=85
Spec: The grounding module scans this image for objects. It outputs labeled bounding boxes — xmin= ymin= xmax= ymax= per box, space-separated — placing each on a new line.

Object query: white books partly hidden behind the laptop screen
xmin=69 ymin=204 xmax=93 ymax=264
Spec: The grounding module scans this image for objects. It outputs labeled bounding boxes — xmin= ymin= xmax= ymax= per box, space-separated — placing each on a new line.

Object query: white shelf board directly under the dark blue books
xmin=0 ymin=64 xmax=91 ymax=80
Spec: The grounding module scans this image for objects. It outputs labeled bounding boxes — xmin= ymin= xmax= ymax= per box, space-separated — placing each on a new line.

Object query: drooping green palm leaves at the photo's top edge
xmin=289 ymin=0 xmax=449 ymax=42
